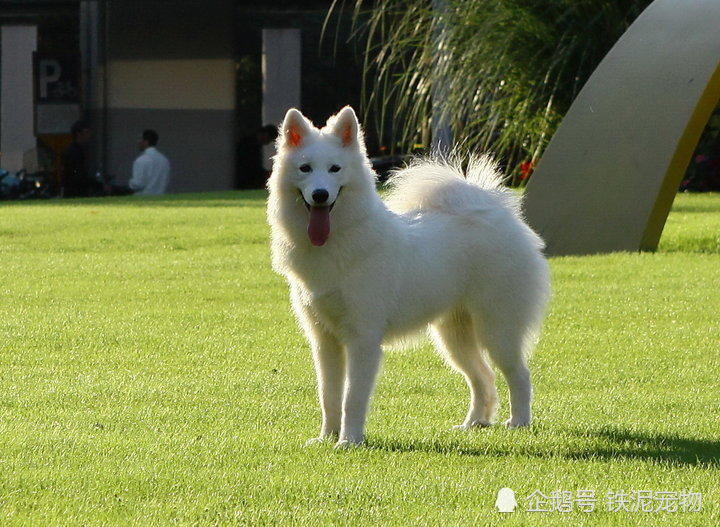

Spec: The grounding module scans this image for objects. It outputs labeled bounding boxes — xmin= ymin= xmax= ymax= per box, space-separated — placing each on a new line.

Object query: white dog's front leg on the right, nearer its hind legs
xmin=335 ymin=338 xmax=382 ymax=448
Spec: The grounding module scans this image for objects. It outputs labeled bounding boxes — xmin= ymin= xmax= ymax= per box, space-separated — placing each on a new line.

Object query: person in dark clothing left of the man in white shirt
xmin=62 ymin=121 xmax=103 ymax=198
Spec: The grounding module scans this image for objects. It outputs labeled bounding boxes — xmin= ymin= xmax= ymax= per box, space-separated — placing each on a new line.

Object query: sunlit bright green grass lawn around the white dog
xmin=0 ymin=192 xmax=720 ymax=526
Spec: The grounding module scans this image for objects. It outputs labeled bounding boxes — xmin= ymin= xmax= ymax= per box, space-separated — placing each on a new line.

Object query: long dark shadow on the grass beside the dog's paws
xmin=368 ymin=427 xmax=720 ymax=466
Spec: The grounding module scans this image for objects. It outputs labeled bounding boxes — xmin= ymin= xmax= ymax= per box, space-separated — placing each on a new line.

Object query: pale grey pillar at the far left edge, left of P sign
xmin=0 ymin=26 xmax=37 ymax=171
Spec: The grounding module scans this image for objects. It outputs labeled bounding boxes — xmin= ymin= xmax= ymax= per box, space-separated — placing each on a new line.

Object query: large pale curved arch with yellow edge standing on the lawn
xmin=525 ymin=0 xmax=720 ymax=255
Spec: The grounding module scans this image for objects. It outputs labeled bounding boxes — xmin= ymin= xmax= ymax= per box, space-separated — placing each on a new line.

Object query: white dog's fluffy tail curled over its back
xmin=385 ymin=155 xmax=520 ymax=215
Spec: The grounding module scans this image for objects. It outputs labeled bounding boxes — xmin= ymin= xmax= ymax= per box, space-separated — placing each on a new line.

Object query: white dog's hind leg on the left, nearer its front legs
xmin=431 ymin=309 xmax=497 ymax=429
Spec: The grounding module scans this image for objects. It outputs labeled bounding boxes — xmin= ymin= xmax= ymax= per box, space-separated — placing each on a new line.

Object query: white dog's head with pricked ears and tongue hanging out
xmin=269 ymin=106 xmax=371 ymax=246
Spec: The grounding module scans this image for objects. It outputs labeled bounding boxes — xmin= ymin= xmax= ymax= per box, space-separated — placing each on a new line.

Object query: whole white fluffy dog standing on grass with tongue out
xmin=268 ymin=107 xmax=549 ymax=447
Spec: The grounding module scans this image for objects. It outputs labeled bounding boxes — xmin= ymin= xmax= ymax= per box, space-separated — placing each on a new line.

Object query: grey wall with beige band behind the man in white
xmin=106 ymin=0 xmax=235 ymax=192
